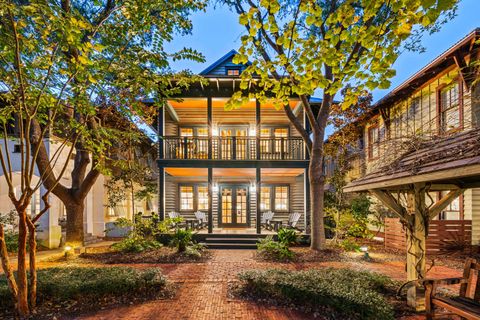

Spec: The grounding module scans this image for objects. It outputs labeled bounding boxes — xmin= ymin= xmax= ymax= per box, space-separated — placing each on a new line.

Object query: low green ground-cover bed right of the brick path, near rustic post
xmin=238 ymin=268 xmax=394 ymax=320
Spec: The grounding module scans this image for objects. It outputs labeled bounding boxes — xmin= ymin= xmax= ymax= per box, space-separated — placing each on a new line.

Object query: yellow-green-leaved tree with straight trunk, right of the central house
xmin=224 ymin=0 xmax=457 ymax=250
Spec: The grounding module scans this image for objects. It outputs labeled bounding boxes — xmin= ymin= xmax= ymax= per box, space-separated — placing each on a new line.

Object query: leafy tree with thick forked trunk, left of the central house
xmin=0 ymin=0 xmax=204 ymax=250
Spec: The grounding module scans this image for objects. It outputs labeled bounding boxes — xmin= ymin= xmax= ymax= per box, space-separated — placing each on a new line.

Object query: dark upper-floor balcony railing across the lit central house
xmin=163 ymin=137 xmax=305 ymax=160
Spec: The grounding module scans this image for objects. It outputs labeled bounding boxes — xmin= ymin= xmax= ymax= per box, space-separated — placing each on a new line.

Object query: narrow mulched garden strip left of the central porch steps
xmin=80 ymin=247 xmax=211 ymax=264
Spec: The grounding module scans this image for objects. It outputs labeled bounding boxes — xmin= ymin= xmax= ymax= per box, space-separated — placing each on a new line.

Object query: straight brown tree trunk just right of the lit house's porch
xmin=308 ymin=137 xmax=325 ymax=250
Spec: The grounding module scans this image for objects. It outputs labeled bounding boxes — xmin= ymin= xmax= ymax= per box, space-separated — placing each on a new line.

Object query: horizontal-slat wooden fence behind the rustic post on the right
xmin=385 ymin=218 xmax=472 ymax=255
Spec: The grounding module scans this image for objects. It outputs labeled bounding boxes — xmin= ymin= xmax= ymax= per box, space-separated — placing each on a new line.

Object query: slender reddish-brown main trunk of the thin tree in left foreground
xmin=17 ymin=208 xmax=30 ymax=318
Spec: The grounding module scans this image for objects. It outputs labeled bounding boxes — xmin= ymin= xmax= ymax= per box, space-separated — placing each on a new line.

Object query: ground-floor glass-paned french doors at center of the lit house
xmin=218 ymin=184 xmax=250 ymax=227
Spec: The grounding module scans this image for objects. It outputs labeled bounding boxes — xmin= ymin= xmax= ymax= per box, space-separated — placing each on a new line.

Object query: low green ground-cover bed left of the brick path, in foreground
xmin=0 ymin=267 xmax=167 ymax=309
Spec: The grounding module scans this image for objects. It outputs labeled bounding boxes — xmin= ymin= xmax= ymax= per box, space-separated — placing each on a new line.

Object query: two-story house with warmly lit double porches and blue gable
xmin=158 ymin=50 xmax=316 ymax=233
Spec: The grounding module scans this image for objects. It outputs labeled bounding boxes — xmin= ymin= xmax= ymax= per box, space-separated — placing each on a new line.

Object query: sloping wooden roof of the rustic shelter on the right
xmin=344 ymin=129 xmax=480 ymax=192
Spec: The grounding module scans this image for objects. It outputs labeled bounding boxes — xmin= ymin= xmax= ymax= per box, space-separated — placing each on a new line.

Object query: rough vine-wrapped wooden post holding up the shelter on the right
xmin=407 ymin=183 xmax=429 ymax=311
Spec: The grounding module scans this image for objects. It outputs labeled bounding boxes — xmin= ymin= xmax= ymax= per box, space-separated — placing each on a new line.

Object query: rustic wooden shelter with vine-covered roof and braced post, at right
xmin=344 ymin=129 xmax=480 ymax=310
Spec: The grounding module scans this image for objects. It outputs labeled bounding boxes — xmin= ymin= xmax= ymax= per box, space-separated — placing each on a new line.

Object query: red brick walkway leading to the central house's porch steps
xmin=73 ymin=250 xmax=459 ymax=320
